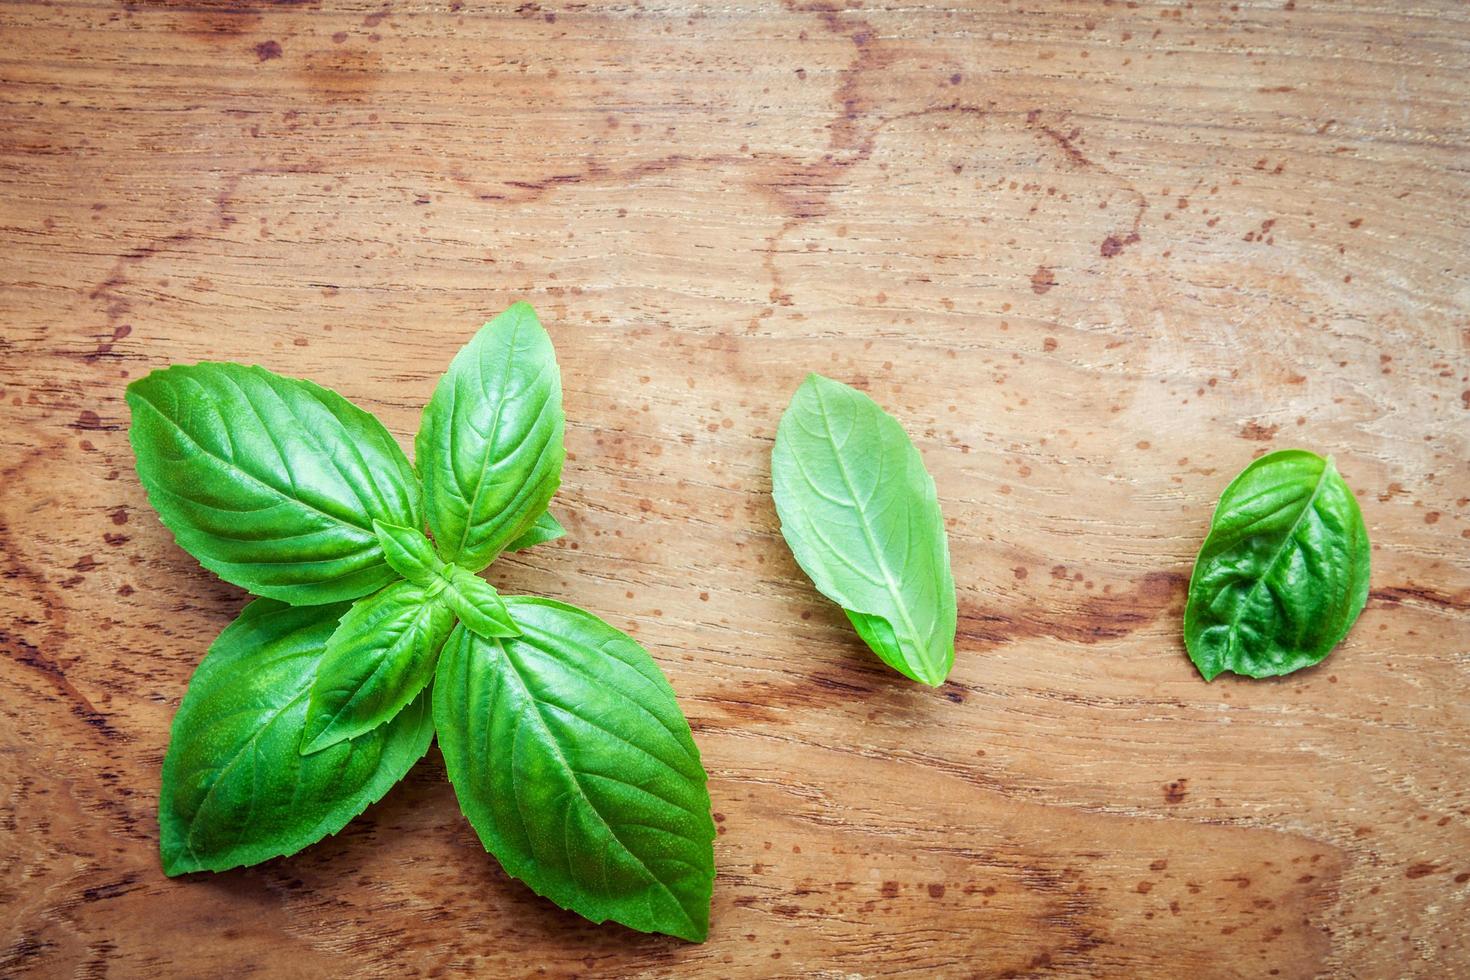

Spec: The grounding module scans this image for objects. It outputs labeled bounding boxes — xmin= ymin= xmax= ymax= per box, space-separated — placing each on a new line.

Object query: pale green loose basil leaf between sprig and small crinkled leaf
xmin=770 ymin=375 xmax=956 ymax=686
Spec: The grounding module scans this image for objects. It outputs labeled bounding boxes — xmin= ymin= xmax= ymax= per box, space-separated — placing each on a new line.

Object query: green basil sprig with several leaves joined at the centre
xmin=128 ymin=303 xmax=714 ymax=940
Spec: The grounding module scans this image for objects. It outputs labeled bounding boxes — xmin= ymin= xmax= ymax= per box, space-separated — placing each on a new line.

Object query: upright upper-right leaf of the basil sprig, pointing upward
xmin=415 ymin=303 xmax=564 ymax=572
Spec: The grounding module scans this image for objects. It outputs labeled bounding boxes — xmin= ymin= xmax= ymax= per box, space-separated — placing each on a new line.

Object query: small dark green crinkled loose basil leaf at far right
xmin=1185 ymin=450 xmax=1369 ymax=680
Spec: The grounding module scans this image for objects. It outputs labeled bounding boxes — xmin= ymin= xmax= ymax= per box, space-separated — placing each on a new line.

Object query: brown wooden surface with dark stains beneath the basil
xmin=0 ymin=0 xmax=1470 ymax=977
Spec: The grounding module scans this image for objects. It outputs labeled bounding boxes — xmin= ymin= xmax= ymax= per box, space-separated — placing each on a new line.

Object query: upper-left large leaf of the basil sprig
xmin=128 ymin=363 xmax=423 ymax=605
